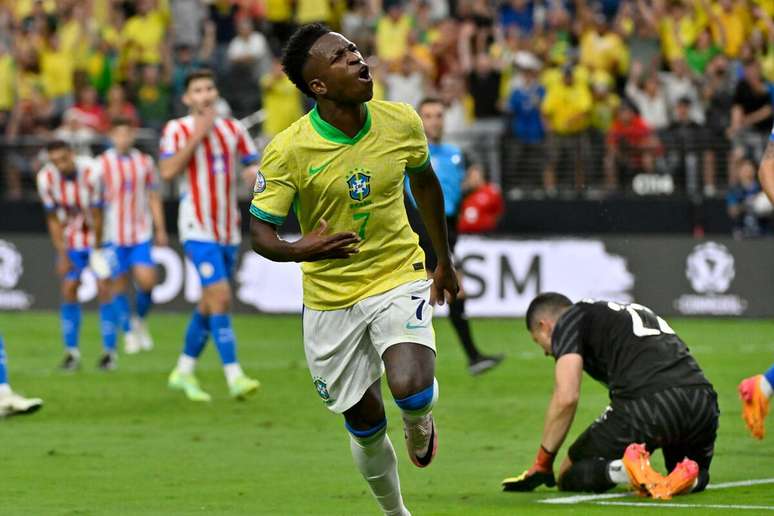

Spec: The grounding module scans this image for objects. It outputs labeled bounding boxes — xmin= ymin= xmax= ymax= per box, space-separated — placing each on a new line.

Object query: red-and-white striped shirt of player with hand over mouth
xmin=161 ymin=116 xmax=258 ymax=244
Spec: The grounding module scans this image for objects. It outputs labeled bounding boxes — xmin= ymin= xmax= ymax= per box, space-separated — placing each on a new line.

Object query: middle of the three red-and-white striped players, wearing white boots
xmin=97 ymin=118 xmax=167 ymax=354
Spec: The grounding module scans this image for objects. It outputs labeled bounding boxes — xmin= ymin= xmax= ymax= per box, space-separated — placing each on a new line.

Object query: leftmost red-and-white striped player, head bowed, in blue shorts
xmin=37 ymin=140 xmax=117 ymax=371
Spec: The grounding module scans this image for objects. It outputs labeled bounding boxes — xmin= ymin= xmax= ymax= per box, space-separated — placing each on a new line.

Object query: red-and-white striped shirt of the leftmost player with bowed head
xmin=37 ymin=157 xmax=102 ymax=251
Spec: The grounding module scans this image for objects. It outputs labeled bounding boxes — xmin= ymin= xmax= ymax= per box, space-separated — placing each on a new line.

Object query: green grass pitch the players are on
xmin=0 ymin=313 xmax=774 ymax=516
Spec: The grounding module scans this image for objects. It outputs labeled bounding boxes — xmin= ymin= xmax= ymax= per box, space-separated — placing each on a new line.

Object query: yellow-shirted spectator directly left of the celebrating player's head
xmin=261 ymin=59 xmax=303 ymax=138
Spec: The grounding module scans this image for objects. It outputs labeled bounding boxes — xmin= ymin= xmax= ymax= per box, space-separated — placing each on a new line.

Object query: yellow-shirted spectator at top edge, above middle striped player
xmin=121 ymin=0 xmax=167 ymax=64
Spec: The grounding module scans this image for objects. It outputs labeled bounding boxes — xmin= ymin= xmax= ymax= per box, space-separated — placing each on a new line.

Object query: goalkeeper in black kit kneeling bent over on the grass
xmin=503 ymin=293 xmax=719 ymax=499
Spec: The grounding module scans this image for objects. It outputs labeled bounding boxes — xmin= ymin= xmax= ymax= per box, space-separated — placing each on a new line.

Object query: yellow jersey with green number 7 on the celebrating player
xmin=255 ymin=101 xmax=430 ymax=310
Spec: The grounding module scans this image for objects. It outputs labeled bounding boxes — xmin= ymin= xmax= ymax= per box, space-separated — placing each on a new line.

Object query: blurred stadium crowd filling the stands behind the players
xmin=0 ymin=0 xmax=774 ymax=220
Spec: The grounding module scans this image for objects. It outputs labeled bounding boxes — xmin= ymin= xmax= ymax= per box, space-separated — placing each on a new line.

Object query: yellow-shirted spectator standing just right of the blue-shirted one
xmin=541 ymin=65 xmax=593 ymax=195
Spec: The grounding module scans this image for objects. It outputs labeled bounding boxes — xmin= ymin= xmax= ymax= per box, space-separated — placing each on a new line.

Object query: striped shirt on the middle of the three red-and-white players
xmin=96 ymin=149 xmax=159 ymax=246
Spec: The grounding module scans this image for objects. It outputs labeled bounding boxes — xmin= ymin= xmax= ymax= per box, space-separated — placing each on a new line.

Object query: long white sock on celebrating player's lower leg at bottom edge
xmin=349 ymin=434 xmax=411 ymax=516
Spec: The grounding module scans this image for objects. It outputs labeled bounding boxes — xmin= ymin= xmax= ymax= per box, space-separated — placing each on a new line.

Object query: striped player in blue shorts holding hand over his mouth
xmin=160 ymin=70 xmax=259 ymax=401
